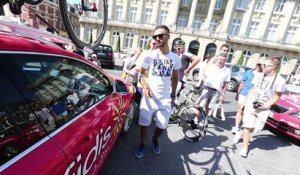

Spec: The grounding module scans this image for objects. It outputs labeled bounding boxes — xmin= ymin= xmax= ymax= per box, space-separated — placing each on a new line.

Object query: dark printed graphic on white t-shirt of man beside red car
xmin=152 ymin=58 xmax=174 ymax=77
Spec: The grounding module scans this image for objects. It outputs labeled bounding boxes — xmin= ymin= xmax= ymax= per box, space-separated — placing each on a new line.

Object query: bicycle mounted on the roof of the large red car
xmin=0 ymin=0 xmax=108 ymax=49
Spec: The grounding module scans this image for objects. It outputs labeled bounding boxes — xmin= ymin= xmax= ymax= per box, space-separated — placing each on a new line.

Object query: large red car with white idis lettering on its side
xmin=0 ymin=23 xmax=135 ymax=175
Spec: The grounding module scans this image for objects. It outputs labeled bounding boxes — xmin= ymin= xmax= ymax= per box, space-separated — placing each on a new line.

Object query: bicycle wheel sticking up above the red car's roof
xmin=59 ymin=0 xmax=107 ymax=49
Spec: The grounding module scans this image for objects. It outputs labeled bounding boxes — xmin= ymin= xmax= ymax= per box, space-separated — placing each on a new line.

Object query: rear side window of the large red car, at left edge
xmin=0 ymin=65 xmax=46 ymax=166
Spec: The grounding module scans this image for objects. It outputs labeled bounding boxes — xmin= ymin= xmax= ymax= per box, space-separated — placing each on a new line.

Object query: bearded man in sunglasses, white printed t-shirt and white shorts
xmin=135 ymin=25 xmax=181 ymax=158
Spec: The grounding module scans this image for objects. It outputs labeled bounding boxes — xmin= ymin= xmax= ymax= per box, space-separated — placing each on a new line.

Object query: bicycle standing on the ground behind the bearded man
xmin=169 ymin=83 xmax=208 ymax=142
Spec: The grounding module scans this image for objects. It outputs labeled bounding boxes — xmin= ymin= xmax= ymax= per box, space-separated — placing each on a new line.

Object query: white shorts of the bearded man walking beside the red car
xmin=139 ymin=96 xmax=171 ymax=129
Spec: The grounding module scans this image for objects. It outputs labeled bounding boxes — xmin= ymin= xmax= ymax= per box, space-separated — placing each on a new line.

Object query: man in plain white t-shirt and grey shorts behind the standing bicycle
xmin=196 ymin=54 xmax=231 ymax=122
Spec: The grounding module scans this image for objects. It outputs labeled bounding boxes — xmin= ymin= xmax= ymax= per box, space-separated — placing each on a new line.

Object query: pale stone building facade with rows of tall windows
xmin=78 ymin=0 xmax=300 ymax=74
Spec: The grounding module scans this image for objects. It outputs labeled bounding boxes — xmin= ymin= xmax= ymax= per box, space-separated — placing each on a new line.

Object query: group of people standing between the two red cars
xmin=118 ymin=25 xmax=286 ymax=158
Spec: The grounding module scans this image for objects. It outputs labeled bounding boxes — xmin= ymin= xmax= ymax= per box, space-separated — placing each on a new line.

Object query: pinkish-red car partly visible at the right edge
xmin=267 ymin=93 xmax=300 ymax=140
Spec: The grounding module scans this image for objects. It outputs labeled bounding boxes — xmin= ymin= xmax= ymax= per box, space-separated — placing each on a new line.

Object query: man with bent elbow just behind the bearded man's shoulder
xmin=175 ymin=39 xmax=200 ymax=97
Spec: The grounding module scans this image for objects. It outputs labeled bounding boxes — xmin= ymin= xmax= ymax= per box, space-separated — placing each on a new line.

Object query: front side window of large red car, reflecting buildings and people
xmin=2 ymin=54 xmax=113 ymax=133
